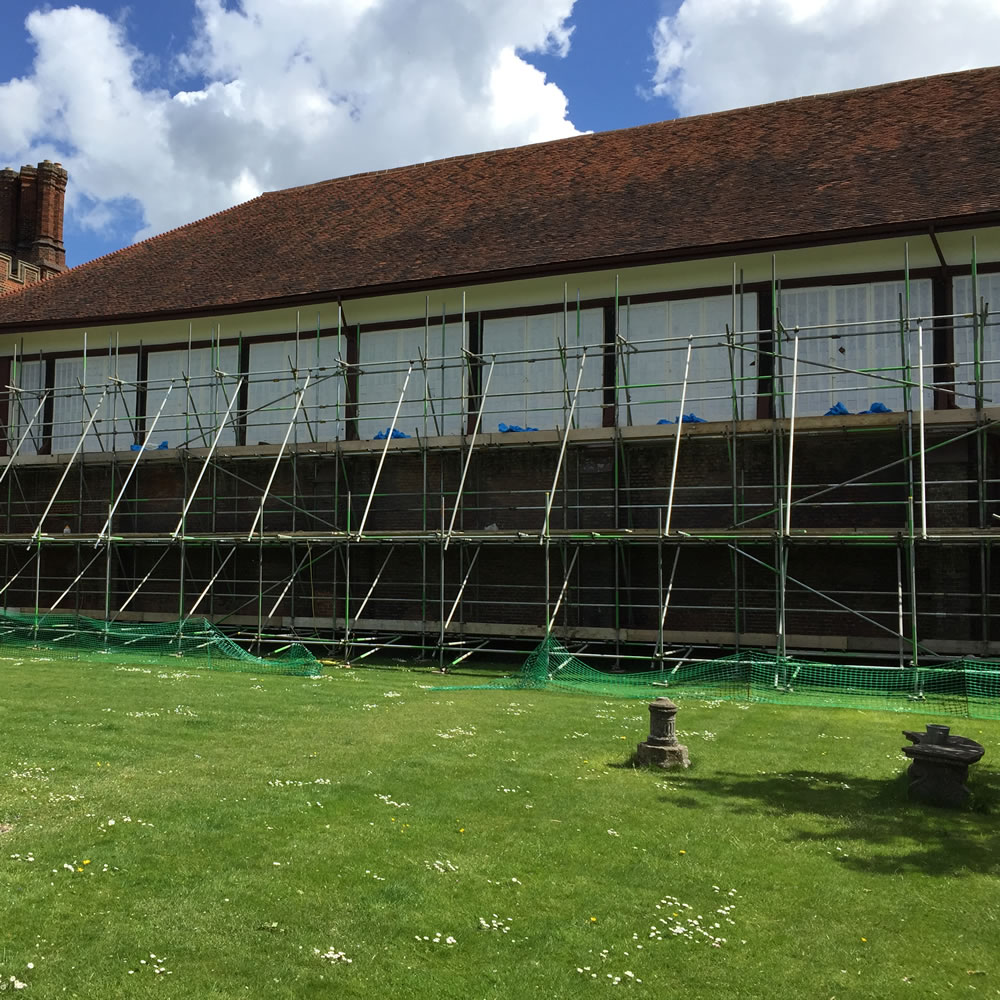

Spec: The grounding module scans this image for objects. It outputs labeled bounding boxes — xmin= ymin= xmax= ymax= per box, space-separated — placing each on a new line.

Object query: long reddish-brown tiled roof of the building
xmin=0 ymin=67 xmax=1000 ymax=329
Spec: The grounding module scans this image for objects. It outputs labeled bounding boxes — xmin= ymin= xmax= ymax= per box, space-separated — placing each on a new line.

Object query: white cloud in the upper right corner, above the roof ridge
xmin=652 ymin=0 xmax=1000 ymax=115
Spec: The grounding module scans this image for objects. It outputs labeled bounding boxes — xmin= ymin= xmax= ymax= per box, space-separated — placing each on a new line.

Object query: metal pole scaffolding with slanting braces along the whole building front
xmin=0 ymin=244 xmax=1000 ymax=684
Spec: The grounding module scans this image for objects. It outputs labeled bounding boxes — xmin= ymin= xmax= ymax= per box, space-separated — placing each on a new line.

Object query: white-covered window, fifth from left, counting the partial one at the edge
xmin=358 ymin=323 xmax=468 ymax=439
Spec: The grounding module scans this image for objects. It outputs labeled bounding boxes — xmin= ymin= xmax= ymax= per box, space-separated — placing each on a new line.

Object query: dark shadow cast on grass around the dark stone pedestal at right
xmin=648 ymin=769 xmax=1000 ymax=875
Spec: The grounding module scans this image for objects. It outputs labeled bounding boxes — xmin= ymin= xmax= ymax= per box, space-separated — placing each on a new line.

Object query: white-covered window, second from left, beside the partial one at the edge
xmin=52 ymin=354 xmax=137 ymax=454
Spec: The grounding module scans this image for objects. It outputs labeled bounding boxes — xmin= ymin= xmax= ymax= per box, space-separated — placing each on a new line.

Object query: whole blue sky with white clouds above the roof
xmin=0 ymin=0 xmax=1000 ymax=265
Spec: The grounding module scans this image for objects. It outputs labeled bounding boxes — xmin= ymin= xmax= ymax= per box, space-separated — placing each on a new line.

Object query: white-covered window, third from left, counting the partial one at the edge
xmin=146 ymin=346 xmax=239 ymax=448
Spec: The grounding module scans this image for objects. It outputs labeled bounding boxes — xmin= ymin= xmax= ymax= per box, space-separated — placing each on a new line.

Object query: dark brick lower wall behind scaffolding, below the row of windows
xmin=0 ymin=430 xmax=1000 ymax=660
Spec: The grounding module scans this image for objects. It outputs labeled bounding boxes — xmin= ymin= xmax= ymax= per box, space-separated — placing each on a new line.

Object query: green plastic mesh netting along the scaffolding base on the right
xmin=435 ymin=637 xmax=1000 ymax=719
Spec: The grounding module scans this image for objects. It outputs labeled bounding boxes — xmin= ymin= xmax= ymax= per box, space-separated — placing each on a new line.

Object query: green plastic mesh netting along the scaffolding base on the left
xmin=0 ymin=611 xmax=321 ymax=676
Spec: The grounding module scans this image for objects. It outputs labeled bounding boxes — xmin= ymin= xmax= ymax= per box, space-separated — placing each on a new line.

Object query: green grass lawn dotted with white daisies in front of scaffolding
xmin=0 ymin=652 xmax=1000 ymax=1000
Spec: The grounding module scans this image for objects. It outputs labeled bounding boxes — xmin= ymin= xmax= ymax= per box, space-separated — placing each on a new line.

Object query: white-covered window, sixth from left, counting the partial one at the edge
xmin=483 ymin=309 xmax=604 ymax=433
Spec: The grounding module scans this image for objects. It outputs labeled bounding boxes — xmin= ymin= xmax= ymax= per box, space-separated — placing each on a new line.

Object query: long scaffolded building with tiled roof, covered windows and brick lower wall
xmin=0 ymin=69 xmax=1000 ymax=663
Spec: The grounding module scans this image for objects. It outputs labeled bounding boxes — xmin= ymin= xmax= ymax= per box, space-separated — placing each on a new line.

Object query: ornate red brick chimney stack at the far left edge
xmin=0 ymin=160 xmax=67 ymax=292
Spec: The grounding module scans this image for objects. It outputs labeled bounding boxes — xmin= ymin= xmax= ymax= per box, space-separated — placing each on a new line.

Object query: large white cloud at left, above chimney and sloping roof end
xmin=0 ymin=0 xmax=576 ymax=250
